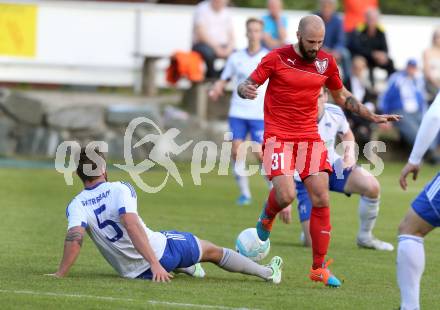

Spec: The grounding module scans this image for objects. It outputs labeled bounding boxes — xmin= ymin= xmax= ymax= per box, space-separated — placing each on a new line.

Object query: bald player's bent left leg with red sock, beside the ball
xmin=256 ymin=175 xmax=295 ymax=241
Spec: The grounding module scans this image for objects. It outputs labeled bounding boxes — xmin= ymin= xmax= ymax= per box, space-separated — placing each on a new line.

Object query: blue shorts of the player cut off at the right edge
xmin=411 ymin=173 xmax=440 ymax=227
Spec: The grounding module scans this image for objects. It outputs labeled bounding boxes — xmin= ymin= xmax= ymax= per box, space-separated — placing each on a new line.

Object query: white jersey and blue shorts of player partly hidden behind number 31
xmin=295 ymin=103 xmax=352 ymax=222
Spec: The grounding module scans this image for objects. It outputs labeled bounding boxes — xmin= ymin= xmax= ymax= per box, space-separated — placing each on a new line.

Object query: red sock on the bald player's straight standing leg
xmin=310 ymin=207 xmax=332 ymax=269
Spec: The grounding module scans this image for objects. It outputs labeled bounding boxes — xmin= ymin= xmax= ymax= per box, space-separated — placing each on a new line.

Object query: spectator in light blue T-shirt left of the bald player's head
xmin=262 ymin=0 xmax=287 ymax=49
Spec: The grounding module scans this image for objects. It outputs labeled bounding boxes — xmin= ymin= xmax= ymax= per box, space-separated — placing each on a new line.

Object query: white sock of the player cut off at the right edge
xmin=397 ymin=235 xmax=425 ymax=310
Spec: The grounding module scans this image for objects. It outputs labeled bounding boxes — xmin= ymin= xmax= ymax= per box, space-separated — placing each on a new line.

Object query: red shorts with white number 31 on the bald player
xmin=263 ymin=137 xmax=332 ymax=180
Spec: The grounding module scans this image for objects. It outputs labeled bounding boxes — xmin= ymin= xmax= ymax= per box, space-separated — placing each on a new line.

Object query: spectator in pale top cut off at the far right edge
xmin=423 ymin=27 xmax=440 ymax=102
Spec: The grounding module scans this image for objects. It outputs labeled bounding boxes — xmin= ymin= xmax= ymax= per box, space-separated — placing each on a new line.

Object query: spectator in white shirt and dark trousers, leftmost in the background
xmin=193 ymin=0 xmax=234 ymax=79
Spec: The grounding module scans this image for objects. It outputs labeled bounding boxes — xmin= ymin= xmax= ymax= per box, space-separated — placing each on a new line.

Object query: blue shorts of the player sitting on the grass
xmin=137 ymin=230 xmax=201 ymax=280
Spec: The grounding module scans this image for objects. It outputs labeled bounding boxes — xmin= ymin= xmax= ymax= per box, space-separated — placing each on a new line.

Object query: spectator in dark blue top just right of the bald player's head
xmin=316 ymin=0 xmax=351 ymax=78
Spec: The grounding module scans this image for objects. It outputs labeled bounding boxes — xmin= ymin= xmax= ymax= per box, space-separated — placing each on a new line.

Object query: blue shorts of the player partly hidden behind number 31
xmin=295 ymin=163 xmax=354 ymax=222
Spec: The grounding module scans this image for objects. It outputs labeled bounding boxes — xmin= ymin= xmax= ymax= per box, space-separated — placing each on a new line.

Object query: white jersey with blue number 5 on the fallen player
xmin=66 ymin=182 xmax=200 ymax=278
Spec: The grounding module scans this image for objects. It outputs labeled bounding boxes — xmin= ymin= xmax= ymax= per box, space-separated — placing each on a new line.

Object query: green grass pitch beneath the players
xmin=0 ymin=163 xmax=440 ymax=309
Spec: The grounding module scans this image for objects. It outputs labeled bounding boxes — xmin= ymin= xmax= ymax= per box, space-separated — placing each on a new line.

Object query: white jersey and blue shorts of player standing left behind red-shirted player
xmin=221 ymin=48 xmax=269 ymax=143
